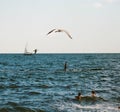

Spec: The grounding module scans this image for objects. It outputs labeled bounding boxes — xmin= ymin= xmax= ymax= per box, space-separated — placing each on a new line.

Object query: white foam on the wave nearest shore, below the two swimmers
xmin=54 ymin=102 xmax=120 ymax=112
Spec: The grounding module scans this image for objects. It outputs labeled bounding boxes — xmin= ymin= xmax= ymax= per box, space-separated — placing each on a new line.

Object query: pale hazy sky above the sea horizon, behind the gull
xmin=0 ymin=0 xmax=120 ymax=53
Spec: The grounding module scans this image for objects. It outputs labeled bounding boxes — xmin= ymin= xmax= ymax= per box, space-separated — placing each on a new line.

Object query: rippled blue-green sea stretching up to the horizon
xmin=0 ymin=53 xmax=120 ymax=112
